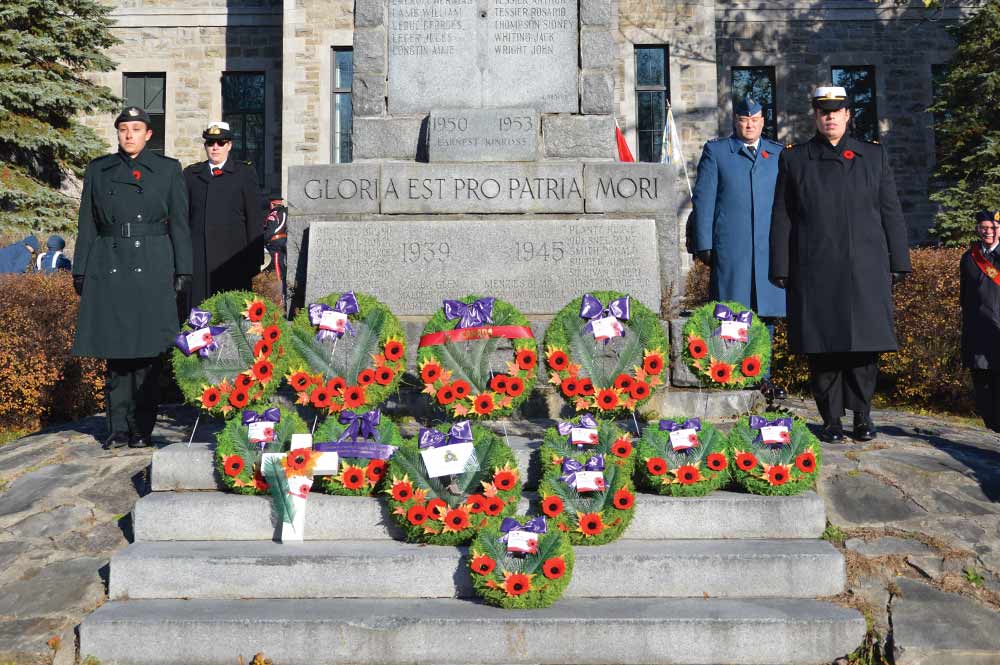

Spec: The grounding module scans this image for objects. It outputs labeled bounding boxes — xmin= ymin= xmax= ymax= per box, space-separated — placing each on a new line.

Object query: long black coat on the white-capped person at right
xmin=770 ymin=135 xmax=910 ymax=353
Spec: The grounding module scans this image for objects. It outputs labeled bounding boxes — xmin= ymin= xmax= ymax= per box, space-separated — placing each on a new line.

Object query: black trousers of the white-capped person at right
xmin=808 ymin=353 xmax=879 ymax=425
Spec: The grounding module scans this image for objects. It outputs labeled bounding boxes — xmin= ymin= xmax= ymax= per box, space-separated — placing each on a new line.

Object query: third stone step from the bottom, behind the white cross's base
xmin=133 ymin=488 xmax=826 ymax=541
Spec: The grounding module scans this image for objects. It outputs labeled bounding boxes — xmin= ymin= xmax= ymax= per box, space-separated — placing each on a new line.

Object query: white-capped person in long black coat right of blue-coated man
xmin=769 ymin=87 xmax=910 ymax=442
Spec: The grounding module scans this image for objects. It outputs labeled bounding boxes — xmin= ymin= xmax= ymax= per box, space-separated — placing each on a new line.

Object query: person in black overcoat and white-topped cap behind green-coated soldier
xmin=184 ymin=122 xmax=264 ymax=308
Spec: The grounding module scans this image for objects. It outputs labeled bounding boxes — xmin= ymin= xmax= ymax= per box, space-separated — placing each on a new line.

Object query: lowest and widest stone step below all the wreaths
xmin=80 ymin=598 xmax=865 ymax=665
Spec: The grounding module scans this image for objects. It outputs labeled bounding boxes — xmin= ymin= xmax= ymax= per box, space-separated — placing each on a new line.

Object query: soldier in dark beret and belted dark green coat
xmin=73 ymin=106 xmax=191 ymax=448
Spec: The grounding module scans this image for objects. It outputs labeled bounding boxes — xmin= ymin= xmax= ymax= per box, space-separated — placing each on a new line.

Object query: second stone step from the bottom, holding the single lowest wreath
xmin=109 ymin=540 xmax=845 ymax=600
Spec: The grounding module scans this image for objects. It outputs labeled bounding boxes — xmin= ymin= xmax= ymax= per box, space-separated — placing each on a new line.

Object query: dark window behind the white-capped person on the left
xmin=222 ymin=72 xmax=266 ymax=186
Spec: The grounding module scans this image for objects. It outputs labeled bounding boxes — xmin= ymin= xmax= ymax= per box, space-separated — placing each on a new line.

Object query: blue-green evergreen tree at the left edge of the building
xmin=0 ymin=0 xmax=118 ymax=232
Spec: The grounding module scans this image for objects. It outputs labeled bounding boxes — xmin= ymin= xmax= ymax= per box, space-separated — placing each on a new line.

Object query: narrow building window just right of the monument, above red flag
xmin=635 ymin=45 xmax=670 ymax=162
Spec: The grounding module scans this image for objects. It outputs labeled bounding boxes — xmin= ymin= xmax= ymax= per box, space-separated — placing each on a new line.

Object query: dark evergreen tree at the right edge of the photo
xmin=930 ymin=0 xmax=1000 ymax=246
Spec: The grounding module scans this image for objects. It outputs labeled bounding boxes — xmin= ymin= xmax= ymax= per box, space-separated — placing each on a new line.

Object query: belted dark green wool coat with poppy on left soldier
xmin=73 ymin=150 xmax=192 ymax=358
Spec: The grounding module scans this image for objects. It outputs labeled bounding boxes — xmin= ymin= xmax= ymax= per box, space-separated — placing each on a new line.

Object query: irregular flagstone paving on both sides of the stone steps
xmin=0 ymin=400 xmax=1000 ymax=665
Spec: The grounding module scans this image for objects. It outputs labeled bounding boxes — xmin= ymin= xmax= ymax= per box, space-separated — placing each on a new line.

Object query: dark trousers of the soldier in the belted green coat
xmin=104 ymin=356 xmax=163 ymax=436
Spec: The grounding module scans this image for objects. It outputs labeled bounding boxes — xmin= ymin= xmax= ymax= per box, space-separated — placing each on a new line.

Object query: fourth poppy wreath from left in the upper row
xmin=544 ymin=291 xmax=669 ymax=417
